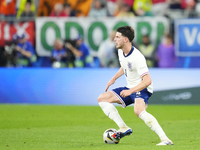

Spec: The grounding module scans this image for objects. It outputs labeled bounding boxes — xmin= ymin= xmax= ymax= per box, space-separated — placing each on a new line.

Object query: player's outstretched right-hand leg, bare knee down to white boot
xmin=134 ymin=98 xmax=173 ymax=145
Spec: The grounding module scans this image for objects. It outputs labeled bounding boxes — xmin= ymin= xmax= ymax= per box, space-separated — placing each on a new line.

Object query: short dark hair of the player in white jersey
xmin=117 ymin=26 xmax=135 ymax=42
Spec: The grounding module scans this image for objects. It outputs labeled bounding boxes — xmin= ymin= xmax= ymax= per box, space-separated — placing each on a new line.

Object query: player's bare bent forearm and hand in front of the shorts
xmin=120 ymin=73 xmax=152 ymax=97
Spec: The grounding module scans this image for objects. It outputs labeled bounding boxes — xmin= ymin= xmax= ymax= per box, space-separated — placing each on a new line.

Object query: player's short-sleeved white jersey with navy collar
xmin=118 ymin=47 xmax=153 ymax=93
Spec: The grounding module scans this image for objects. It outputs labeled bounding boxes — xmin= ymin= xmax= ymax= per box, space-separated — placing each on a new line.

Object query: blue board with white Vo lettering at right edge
xmin=175 ymin=19 xmax=200 ymax=57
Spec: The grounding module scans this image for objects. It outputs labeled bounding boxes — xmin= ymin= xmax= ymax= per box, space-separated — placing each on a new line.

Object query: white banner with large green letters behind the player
xmin=36 ymin=17 xmax=170 ymax=56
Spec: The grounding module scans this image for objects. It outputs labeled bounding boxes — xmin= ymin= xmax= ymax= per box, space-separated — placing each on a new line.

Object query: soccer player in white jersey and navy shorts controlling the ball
xmin=98 ymin=26 xmax=173 ymax=145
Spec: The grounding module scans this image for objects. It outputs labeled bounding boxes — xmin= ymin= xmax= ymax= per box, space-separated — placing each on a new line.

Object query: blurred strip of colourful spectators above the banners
xmin=0 ymin=0 xmax=200 ymax=19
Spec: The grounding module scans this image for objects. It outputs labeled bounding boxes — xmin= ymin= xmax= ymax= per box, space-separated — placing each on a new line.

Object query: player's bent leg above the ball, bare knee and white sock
xmin=98 ymin=91 xmax=127 ymax=129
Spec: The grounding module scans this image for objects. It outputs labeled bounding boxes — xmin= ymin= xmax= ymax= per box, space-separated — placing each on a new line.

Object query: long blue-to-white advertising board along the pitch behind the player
xmin=0 ymin=68 xmax=200 ymax=105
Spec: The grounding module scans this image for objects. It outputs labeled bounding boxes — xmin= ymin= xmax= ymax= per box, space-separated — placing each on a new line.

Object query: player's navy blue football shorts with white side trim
xmin=111 ymin=87 xmax=152 ymax=108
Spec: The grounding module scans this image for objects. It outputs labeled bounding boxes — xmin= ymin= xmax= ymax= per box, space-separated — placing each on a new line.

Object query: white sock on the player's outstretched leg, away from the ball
xmin=139 ymin=110 xmax=169 ymax=141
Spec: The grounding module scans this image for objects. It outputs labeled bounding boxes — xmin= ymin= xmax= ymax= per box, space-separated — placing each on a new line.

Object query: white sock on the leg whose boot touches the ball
xmin=99 ymin=102 xmax=127 ymax=128
